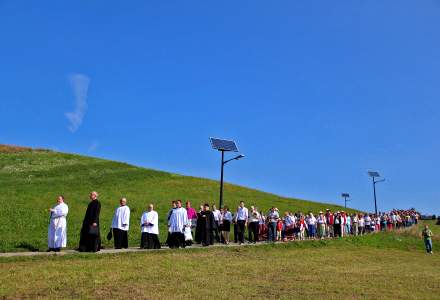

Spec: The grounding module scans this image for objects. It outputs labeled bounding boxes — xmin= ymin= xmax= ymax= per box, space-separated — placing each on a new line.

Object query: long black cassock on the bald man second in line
xmin=78 ymin=199 xmax=101 ymax=252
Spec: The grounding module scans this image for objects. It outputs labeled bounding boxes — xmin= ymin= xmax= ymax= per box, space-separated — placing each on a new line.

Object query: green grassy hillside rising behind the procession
xmin=0 ymin=145 xmax=356 ymax=252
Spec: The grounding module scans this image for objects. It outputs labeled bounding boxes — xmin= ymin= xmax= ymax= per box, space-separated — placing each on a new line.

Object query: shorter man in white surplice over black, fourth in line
xmin=141 ymin=204 xmax=160 ymax=249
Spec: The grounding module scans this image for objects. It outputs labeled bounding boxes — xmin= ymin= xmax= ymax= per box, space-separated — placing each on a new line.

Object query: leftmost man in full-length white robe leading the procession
xmin=47 ymin=196 xmax=69 ymax=252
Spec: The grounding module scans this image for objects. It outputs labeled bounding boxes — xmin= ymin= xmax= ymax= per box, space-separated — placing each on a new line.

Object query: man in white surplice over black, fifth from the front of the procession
xmin=168 ymin=200 xmax=190 ymax=248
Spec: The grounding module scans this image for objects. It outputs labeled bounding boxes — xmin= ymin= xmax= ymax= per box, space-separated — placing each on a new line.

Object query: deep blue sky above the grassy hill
xmin=0 ymin=0 xmax=440 ymax=214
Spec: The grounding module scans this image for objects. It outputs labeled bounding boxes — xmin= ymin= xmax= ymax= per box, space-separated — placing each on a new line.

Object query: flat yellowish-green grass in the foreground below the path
xmin=0 ymin=222 xmax=440 ymax=299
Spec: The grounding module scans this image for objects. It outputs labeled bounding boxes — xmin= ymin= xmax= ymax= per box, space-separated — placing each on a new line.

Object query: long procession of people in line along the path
xmin=48 ymin=192 xmax=432 ymax=252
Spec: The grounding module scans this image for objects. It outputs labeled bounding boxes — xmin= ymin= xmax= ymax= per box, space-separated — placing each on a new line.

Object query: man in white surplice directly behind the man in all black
xmin=112 ymin=198 xmax=130 ymax=249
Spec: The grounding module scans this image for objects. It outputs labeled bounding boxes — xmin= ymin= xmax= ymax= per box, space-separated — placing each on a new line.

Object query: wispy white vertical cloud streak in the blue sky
xmin=65 ymin=74 xmax=90 ymax=133
